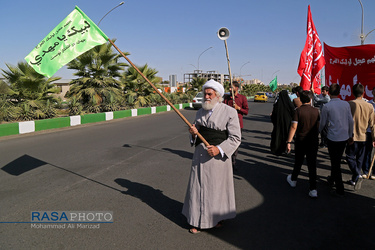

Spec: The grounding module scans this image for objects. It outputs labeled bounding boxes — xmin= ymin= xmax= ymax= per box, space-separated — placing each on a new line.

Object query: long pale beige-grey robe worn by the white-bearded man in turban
xmin=182 ymin=103 xmax=241 ymax=229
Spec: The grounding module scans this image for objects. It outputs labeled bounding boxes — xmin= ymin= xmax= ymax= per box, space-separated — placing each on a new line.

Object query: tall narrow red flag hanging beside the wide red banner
xmin=297 ymin=5 xmax=325 ymax=92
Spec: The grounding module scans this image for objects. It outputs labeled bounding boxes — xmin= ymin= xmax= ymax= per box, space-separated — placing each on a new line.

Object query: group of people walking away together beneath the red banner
xmin=270 ymin=84 xmax=375 ymax=198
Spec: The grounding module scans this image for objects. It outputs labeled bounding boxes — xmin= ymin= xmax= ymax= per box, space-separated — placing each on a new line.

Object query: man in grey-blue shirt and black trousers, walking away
xmin=319 ymin=83 xmax=353 ymax=196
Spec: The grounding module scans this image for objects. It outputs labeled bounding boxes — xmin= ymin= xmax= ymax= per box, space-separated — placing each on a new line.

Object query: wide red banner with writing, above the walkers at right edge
xmin=324 ymin=44 xmax=375 ymax=101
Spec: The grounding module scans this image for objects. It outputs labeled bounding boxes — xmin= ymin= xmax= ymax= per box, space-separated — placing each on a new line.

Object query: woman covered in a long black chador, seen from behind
xmin=271 ymin=90 xmax=294 ymax=155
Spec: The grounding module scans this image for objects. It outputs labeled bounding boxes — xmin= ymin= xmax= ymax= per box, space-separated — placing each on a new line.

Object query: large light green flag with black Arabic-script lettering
xmin=25 ymin=6 xmax=108 ymax=77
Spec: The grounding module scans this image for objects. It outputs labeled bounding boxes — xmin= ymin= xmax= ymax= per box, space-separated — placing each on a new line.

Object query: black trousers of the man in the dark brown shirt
xmin=292 ymin=138 xmax=318 ymax=190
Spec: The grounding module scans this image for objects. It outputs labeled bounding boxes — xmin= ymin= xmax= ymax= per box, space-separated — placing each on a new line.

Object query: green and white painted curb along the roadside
xmin=0 ymin=103 xmax=193 ymax=137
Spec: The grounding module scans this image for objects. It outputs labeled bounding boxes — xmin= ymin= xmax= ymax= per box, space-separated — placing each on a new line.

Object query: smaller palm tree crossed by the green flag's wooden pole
xmin=122 ymin=64 xmax=160 ymax=108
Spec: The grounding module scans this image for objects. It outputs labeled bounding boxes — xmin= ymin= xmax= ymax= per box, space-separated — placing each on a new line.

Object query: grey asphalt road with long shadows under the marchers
xmin=0 ymin=101 xmax=375 ymax=249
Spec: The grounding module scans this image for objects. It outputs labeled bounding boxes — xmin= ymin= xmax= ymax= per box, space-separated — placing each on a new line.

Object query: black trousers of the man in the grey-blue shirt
xmin=327 ymin=139 xmax=347 ymax=194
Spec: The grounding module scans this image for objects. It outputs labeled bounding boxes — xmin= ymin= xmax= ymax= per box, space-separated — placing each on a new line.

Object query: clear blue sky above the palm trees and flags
xmin=0 ymin=0 xmax=375 ymax=84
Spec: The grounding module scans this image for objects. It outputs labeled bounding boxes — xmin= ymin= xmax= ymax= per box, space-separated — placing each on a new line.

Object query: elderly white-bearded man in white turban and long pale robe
xmin=182 ymin=80 xmax=241 ymax=234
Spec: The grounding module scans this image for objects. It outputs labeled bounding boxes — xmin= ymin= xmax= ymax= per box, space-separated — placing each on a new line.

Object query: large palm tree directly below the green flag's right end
xmin=66 ymin=40 xmax=129 ymax=108
